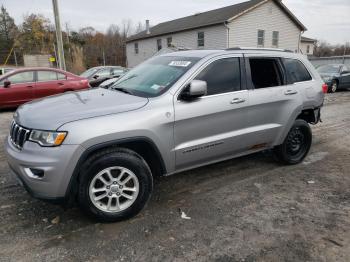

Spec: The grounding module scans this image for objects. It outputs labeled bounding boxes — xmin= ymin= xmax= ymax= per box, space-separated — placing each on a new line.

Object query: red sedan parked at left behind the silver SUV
xmin=0 ymin=68 xmax=89 ymax=108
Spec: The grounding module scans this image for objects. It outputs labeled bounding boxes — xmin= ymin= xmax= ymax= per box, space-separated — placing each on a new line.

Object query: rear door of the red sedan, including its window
xmin=34 ymin=70 xmax=67 ymax=98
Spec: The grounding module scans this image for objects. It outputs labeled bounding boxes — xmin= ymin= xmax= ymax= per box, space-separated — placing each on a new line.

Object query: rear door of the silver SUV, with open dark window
xmin=245 ymin=54 xmax=301 ymax=149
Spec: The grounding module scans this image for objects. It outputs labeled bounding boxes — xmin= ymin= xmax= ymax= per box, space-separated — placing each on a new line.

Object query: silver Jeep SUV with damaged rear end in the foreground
xmin=5 ymin=48 xmax=327 ymax=221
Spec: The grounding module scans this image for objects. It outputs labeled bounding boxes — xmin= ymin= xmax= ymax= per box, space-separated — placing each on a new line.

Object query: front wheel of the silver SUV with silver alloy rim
xmin=78 ymin=148 xmax=153 ymax=222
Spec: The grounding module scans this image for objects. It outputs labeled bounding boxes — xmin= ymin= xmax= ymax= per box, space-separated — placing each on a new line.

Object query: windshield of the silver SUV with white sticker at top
xmin=111 ymin=56 xmax=200 ymax=97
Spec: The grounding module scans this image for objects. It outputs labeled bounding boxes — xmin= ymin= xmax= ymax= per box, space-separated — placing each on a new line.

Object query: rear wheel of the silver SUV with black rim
xmin=274 ymin=119 xmax=312 ymax=165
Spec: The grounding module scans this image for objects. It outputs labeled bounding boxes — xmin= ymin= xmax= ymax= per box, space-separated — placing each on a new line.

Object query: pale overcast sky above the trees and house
xmin=1 ymin=0 xmax=350 ymax=44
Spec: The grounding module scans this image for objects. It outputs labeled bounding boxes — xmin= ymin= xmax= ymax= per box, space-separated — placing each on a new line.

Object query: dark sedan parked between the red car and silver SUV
xmin=80 ymin=66 xmax=128 ymax=87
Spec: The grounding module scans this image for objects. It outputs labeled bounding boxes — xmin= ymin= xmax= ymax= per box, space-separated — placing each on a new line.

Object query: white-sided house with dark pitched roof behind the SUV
xmin=126 ymin=0 xmax=306 ymax=67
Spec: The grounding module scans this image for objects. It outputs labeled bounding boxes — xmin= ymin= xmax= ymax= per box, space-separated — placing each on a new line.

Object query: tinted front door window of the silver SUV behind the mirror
xmin=196 ymin=57 xmax=241 ymax=95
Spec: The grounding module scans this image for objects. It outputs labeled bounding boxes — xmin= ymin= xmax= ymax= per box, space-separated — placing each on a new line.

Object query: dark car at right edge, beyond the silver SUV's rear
xmin=317 ymin=64 xmax=350 ymax=93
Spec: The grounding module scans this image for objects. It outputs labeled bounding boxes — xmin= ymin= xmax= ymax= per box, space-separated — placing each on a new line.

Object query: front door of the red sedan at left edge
xmin=0 ymin=71 xmax=35 ymax=107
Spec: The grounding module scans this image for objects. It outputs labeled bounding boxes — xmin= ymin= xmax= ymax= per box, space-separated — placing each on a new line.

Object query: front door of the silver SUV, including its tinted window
xmin=174 ymin=55 xmax=249 ymax=170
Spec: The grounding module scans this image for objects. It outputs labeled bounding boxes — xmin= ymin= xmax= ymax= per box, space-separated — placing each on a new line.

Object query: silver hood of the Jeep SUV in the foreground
xmin=14 ymin=88 xmax=148 ymax=130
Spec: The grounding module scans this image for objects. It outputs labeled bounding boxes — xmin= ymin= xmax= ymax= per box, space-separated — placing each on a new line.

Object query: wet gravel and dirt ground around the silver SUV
xmin=0 ymin=91 xmax=350 ymax=261
